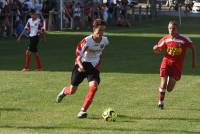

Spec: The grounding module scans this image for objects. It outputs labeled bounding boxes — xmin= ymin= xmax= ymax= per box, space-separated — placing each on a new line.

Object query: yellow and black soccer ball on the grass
xmin=102 ymin=108 xmax=117 ymax=122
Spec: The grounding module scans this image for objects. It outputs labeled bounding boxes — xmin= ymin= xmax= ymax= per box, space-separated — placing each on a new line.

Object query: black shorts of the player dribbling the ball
xmin=71 ymin=62 xmax=100 ymax=86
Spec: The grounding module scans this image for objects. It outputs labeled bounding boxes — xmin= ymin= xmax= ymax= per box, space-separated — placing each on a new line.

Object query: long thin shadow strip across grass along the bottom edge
xmin=0 ymin=125 xmax=199 ymax=134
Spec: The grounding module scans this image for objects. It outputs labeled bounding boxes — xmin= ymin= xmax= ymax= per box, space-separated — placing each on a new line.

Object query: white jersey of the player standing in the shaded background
xmin=25 ymin=18 xmax=45 ymax=37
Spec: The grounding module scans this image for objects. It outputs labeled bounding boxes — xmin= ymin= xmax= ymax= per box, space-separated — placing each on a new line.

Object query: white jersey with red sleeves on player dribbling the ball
xmin=75 ymin=35 xmax=109 ymax=68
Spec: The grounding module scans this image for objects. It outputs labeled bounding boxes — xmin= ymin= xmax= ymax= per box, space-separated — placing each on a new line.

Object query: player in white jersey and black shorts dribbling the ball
xmin=56 ymin=19 xmax=109 ymax=118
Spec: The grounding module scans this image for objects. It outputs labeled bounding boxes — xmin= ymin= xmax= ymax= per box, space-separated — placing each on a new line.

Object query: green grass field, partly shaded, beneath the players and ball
xmin=0 ymin=18 xmax=200 ymax=134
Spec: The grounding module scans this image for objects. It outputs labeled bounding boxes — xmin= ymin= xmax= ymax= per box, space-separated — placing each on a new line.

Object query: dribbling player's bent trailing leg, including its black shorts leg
xmin=56 ymin=65 xmax=85 ymax=103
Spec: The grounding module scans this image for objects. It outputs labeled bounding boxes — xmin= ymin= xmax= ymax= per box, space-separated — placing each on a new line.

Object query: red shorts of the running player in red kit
xmin=160 ymin=66 xmax=181 ymax=81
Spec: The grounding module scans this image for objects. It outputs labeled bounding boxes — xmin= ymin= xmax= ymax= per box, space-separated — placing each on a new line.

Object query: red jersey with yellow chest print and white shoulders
xmin=157 ymin=34 xmax=193 ymax=71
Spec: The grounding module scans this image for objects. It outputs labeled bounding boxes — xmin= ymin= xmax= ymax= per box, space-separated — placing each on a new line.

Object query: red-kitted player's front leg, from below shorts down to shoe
xmin=158 ymin=76 xmax=168 ymax=109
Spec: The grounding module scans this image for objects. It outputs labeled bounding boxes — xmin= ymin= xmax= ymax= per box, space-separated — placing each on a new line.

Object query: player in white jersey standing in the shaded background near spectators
xmin=17 ymin=9 xmax=45 ymax=71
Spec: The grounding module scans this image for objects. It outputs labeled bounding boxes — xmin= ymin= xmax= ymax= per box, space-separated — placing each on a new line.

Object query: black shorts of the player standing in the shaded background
xmin=28 ymin=36 xmax=39 ymax=53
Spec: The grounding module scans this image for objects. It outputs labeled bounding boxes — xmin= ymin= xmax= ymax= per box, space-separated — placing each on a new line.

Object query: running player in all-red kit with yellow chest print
xmin=153 ymin=21 xmax=196 ymax=109
